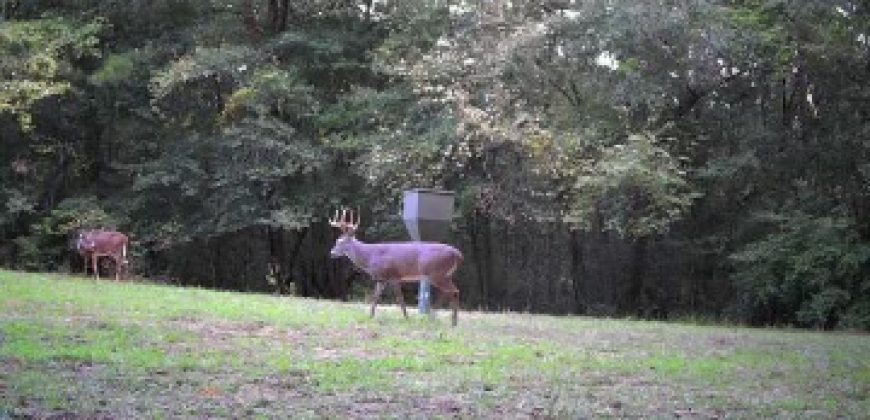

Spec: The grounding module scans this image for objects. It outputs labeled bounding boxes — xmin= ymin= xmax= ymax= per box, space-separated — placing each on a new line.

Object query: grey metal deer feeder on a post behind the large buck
xmin=402 ymin=188 xmax=454 ymax=314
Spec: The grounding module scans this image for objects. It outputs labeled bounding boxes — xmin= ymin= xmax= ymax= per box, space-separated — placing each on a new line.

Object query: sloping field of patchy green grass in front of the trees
xmin=0 ymin=271 xmax=870 ymax=418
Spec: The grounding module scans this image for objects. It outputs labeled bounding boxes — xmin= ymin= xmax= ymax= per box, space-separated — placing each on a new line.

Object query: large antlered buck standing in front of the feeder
xmin=329 ymin=209 xmax=462 ymax=326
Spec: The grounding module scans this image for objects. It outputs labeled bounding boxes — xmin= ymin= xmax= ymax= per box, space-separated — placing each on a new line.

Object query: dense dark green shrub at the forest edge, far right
xmin=731 ymin=213 xmax=870 ymax=329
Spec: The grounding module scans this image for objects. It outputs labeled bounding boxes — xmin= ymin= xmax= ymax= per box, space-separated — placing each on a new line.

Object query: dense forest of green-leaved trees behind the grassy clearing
xmin=0 ymin=0 xmax=870 ymax=330
